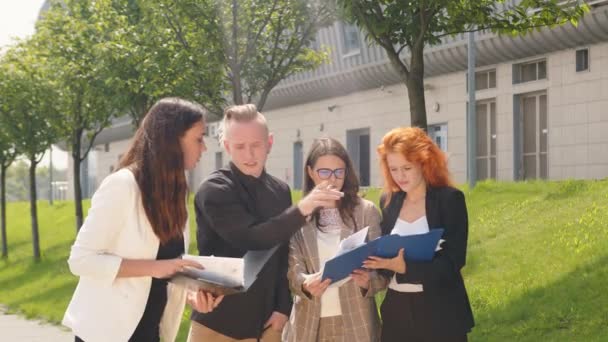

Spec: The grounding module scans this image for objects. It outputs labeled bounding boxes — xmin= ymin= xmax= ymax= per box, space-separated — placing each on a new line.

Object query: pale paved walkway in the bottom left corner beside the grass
xmin=0 ymin=307 xmax=74 ymax=342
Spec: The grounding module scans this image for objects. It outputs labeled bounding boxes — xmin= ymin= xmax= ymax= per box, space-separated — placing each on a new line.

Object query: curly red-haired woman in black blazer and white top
xmin=364 ymin=127 xmax=474 ymax=342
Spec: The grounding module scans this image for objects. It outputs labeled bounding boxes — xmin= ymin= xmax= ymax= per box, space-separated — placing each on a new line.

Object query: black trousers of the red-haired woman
xmin=380 ymin=289 xmax=467 ymax=342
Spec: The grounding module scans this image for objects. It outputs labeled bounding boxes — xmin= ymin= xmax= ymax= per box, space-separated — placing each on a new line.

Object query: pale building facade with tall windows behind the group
xmin=69 ymin=1 xmax=608 ymax=195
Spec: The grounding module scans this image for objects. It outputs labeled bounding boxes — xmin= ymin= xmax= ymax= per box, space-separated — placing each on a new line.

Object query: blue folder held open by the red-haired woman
xmin=321 ymin=228 xmax=443 ymax=283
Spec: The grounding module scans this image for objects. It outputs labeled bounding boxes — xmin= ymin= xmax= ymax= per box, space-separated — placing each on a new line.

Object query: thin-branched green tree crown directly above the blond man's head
xmin=155 ymin=0 xmax=334 ymax=110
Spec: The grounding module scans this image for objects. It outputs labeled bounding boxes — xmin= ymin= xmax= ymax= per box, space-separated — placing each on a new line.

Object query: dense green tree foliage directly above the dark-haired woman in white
xmin=99 ymin=0 xmax=223 ymax=127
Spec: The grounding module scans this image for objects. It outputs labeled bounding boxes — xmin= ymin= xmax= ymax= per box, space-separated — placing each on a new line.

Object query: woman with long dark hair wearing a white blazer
xmin=63 ymin=98 xmax=221 ymax=342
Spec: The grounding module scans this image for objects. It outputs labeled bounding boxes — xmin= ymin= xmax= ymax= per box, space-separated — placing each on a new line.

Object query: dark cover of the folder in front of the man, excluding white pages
xmin=170 ymin=247 xmax=278 ymax=295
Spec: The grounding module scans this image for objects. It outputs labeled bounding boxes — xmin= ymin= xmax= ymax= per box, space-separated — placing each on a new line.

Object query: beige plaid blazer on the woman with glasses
xmin=283 ymin=199 xmax=386 ymax=342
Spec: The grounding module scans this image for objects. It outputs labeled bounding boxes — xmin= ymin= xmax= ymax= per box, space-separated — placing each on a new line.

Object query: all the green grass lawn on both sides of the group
xmin=0 ymin=180 xmax=608 ymax=341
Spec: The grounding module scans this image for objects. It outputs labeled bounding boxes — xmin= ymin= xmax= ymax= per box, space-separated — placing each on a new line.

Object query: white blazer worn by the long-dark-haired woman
xmin=62 ymin=169 xmax=189 ymax=342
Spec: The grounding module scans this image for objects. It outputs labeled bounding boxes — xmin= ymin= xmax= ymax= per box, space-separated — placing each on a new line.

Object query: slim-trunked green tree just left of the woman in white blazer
xmin=34 ymin=0 xmax=120 ymax=229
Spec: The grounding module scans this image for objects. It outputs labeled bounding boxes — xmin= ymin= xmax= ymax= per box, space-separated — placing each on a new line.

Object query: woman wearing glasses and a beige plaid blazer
xmin=284 ymin=138 xmax=386 ymax=342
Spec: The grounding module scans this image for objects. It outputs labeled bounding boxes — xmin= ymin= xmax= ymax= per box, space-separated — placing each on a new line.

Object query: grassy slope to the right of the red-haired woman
xmin=464 ymin=180 xmax=608 ymax=341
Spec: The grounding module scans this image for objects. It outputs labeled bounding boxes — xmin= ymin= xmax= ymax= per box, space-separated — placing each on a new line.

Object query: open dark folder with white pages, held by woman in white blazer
xmin=170 ymin=246 xmax=278 ymax=295
